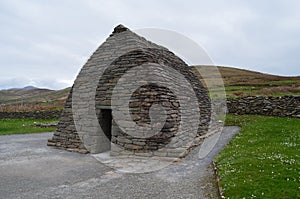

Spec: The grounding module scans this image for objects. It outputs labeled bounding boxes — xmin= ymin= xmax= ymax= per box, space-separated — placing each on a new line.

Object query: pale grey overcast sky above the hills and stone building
xmin=0 ymin=0 xmax=300 ymax=89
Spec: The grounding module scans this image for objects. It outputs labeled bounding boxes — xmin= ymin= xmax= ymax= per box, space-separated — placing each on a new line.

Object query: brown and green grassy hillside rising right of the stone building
xmin=193 ymin=66 xmax=300 ymax=97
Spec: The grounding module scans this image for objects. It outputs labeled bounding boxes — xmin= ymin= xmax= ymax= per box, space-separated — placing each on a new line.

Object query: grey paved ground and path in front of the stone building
xmin=0 ymin=127 xmax=239 ymax=199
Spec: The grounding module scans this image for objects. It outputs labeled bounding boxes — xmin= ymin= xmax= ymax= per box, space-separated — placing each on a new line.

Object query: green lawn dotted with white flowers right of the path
xmin=215 ymin=115 xmax=300 ymax=198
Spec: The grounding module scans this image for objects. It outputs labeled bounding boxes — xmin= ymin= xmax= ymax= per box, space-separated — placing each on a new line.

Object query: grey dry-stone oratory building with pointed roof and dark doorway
xmin=48 ymin=25 xmax=211 ymax=157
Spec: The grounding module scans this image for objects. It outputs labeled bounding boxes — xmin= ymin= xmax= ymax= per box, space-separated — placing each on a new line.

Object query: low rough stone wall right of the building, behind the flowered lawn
xmin=227 ymin=96 xmax=300 ymax=118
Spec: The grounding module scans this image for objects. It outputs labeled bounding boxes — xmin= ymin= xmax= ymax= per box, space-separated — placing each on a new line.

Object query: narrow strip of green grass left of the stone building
xmin=0 ymin=119 xmax=57 ymax=135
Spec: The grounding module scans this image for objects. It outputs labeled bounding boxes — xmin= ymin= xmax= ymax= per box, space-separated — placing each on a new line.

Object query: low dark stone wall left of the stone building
xmin=0 ymin=110 xmax=62 ymax=120
